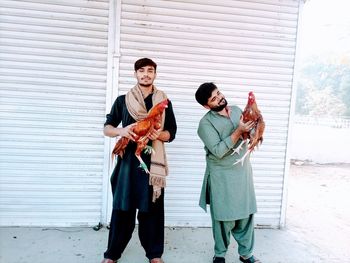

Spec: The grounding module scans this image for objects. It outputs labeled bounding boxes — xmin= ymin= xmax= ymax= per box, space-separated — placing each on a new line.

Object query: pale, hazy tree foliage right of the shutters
xmin=296 ymin=57 xmax=350 ymax=116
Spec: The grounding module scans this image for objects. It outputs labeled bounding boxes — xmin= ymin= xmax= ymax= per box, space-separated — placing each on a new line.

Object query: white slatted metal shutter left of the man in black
xmin=0 ymin=0 xmax=109 ymax=226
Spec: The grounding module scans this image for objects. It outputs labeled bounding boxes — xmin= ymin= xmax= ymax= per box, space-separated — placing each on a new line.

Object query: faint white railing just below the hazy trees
xmin=294 ymin=115 xmax=350 ymax=128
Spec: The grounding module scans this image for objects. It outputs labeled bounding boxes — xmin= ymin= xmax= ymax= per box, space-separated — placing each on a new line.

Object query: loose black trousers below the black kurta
xmin=104 ymin=199 xmax=164 ymax=260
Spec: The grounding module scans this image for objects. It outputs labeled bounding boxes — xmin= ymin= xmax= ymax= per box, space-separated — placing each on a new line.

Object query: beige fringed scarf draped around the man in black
xmin=125 ymin=85 xmax=168 ymax=202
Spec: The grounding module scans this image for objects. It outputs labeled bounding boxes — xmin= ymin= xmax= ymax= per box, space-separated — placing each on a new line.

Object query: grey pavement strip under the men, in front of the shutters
xmin=0 ymin=227 xmax=334 ymax=263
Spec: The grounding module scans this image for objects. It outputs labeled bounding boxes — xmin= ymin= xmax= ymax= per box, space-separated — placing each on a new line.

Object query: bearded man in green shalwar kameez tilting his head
xmin=195 ymin=83 xmax=261 ymax=263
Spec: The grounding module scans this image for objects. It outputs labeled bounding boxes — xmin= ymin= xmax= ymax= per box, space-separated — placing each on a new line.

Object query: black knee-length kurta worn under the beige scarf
xmin=105 ymin=94 xmax=177 ymax=212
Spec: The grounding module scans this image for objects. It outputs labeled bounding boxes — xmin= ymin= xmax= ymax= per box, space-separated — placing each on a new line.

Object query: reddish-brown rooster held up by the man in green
xmin=232 ymin=91 xmax=265 ymax=165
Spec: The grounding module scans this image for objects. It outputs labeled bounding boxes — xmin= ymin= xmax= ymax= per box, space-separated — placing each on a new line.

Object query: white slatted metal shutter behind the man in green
xmin=119 ymin=0 xmax=299 ymax=227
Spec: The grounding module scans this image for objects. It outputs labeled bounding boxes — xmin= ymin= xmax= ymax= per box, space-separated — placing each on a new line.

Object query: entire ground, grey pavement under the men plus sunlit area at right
xmin=0 ymin=165 xmax=350 ymax=263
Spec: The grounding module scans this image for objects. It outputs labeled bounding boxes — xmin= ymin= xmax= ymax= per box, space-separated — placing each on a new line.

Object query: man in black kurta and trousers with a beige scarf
xmin=102 ymin=58 xmax=177 ymax=263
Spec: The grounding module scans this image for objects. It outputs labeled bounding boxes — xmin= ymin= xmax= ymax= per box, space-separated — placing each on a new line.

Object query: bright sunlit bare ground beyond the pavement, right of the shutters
xmin=286 ymin=164 xmax=350 ymax=263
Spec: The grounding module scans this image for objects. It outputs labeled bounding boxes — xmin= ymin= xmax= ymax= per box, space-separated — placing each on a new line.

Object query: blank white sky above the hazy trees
xmin=300 ymin=0 xmax=350 ymax=57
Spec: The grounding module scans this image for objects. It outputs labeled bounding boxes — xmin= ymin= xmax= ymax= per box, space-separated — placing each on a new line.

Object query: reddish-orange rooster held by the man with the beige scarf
xmin=112 ymin=99 xmax=169 ymax=174
